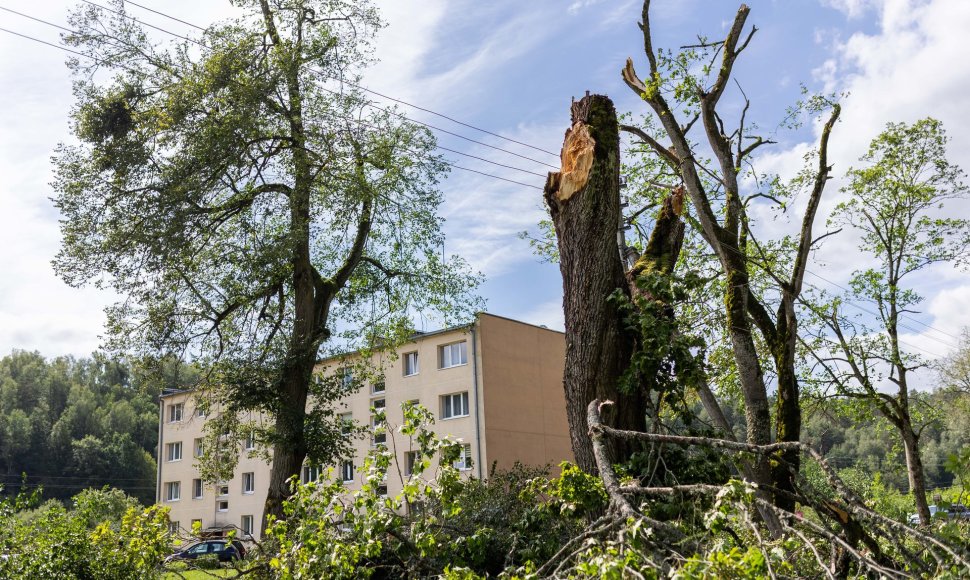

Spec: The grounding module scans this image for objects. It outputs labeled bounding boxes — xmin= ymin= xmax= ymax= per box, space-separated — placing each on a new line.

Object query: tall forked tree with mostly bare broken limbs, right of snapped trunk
xmin=622 ymin=0 xmax=840 ymax=509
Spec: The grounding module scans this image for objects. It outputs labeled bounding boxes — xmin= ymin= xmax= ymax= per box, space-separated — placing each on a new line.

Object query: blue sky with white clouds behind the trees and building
xmin=0 ymin=0 xmax=970 ymax=376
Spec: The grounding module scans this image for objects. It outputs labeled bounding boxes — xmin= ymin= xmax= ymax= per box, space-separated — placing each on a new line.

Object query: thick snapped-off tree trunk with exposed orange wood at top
xmin=545 ymin=95 xmax=646 ymax=473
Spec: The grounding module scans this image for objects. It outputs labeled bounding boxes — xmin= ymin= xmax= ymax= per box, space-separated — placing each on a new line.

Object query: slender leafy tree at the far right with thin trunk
xmin=815 ymin=118 xmax=970 ymax=524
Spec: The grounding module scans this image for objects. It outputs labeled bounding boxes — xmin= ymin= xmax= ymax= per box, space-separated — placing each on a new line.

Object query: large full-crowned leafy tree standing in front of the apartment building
xmin=54 ymin=0 xmax=477 ymax=524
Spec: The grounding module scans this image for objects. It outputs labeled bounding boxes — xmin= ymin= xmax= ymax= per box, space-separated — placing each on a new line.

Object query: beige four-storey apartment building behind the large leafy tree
xmin=157 ymin=313 xmax=572 ymax=537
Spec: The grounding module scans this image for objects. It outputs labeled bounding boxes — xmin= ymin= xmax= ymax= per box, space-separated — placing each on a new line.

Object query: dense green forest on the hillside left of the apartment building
xmin=0 ymin=351 xmax=176 ymax=504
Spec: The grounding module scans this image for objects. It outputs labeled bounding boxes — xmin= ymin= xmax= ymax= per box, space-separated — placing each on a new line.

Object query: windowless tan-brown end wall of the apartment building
xmin=478 ymin=314 xmax=573 ymax=473
